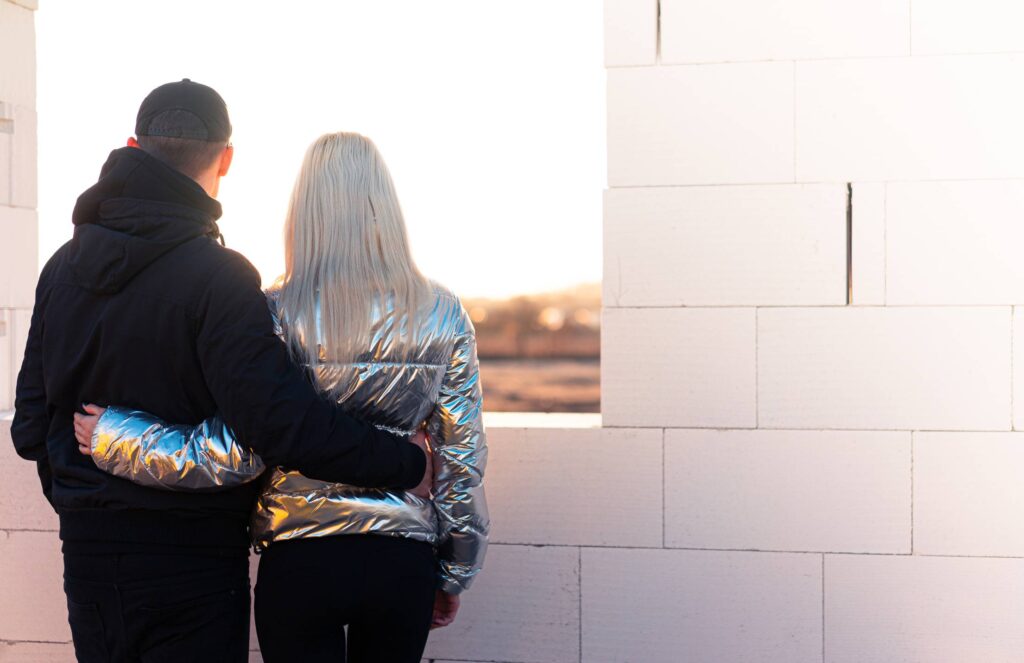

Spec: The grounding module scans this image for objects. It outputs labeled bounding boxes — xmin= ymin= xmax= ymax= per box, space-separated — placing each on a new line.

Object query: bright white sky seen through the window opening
xmin=37 ymin=0 xmax=606 ymax=296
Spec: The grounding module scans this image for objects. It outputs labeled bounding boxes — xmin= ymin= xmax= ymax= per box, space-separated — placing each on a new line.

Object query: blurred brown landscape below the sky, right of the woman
xmin=464 ymin=283 xmax=601 ymax=412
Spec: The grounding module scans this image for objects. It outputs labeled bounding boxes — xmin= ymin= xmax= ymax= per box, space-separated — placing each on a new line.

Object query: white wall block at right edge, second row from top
xmin=794 ymin=55 xmax=1024 ymax=181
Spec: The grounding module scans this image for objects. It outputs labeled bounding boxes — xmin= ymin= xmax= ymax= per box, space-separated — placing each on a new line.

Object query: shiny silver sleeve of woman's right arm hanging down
xmin=427 ymin=310 xmax=490 ymax=594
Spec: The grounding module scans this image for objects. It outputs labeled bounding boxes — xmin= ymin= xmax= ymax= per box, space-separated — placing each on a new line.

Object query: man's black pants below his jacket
xmin=65 ymin=552 xmax=249 ymax=663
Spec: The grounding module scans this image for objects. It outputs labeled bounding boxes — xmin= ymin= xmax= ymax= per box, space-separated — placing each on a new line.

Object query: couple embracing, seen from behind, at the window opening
xmin=11 ymin=79 xmax=488 ymax=663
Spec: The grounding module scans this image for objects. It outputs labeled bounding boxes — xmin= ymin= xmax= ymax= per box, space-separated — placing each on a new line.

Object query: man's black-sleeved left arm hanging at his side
xmin=10 ymin=271 xmax=52 ymax=499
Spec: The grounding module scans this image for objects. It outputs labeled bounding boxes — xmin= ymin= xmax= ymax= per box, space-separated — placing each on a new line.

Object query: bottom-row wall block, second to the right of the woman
xmin=582 ymin=548 xmax=821 ymax=663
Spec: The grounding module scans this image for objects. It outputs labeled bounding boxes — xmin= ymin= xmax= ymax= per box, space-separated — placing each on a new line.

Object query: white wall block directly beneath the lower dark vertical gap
xmin=758 ymin=307 xmax=1011 ymax=430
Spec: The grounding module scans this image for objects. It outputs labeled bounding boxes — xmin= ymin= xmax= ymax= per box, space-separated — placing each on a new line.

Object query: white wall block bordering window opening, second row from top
xmin=608 ymin=63 xmax=794 ymax=187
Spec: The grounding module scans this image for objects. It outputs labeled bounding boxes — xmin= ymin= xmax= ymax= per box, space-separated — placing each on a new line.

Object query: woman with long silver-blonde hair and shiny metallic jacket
xmin=76 ymin=133 xmax=489 ymax=663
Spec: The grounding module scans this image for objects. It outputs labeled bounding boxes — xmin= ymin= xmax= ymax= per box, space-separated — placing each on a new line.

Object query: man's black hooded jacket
xmin=11 ymin=148 xmax=425 ymax=549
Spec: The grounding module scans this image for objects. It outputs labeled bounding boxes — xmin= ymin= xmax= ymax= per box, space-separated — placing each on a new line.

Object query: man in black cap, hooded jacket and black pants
xmin=11 ymin=79 xmax=429 ymax=663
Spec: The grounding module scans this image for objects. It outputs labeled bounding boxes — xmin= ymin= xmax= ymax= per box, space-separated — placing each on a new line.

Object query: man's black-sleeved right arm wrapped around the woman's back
xmin=197 ymin=253 xmax=426 ymax=489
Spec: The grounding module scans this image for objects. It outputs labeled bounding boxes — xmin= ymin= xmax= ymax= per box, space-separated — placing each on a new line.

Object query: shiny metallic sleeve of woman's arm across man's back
xmin=92 ymin=407 xmax=264 ymax=491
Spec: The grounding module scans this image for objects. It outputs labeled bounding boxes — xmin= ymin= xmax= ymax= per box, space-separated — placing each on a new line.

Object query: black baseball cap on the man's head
xmin=135 ymin=78 xmax=231 ymax=142
